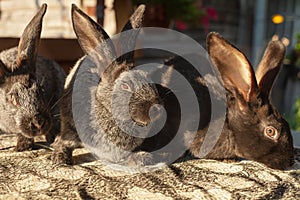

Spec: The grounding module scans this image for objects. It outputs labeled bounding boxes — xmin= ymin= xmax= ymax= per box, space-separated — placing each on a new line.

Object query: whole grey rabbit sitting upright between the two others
xmin=51 ymin=4 xmax=166 ymax=165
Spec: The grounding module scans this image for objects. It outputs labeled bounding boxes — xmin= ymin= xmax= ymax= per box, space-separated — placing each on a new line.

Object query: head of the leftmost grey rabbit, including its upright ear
xmin=0 ymin=4 xmax=51 ymax=138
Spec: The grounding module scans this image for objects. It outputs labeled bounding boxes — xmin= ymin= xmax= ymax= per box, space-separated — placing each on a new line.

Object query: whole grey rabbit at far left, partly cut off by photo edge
xmin=0 ymin=4 xmax=66 ymax=151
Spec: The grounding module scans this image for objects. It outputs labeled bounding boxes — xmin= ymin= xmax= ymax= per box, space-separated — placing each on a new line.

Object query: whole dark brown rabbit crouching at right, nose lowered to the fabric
xmin=164 ymin=32 xmax=294 ymax=169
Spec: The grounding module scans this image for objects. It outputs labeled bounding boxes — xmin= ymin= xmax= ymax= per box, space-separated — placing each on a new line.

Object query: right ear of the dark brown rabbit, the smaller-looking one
xmin=255 ymin=40 xmax=285 ymax=97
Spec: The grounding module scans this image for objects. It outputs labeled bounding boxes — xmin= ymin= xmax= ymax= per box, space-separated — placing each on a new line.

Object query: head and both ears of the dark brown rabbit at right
xmin=207 ymin=33 xmax=294 ymax=169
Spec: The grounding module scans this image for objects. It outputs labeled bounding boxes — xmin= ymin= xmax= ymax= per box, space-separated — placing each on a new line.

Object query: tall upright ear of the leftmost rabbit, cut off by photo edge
xmin=17 ymin=4 xmax=47 ymax=70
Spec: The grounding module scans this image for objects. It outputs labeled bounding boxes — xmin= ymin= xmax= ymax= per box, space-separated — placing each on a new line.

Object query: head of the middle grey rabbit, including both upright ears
xmin=72 ymin=5 xmax=160 ymax=131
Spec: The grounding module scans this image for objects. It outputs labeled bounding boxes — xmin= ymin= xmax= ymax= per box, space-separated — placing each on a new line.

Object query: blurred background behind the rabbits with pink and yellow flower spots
xmin=0 ymin=0 xmax=300 ymax=131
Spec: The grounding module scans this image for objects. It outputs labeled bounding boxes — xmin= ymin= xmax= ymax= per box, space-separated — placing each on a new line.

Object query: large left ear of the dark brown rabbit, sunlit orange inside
xmin=207 ymin=32 xmax=257 ymax=102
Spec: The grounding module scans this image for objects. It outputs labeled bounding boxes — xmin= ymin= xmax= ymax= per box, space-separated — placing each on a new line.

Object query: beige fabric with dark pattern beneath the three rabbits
xmin=0 ymin=134 xmax=300 ymax=200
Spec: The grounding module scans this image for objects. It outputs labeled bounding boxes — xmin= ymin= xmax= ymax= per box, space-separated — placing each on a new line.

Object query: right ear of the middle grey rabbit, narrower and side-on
xmin=117 ymin=5 xmax=145 ymax=66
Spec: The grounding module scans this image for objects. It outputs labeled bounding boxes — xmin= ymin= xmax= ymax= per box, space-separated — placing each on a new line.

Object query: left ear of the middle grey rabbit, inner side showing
xmin=72 ymin=4 xmax=116 ymax=69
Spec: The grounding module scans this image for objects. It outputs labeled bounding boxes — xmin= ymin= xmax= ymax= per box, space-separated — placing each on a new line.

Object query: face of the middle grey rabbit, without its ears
xmin=108 ymin=70 xmax=161 ymax=126
